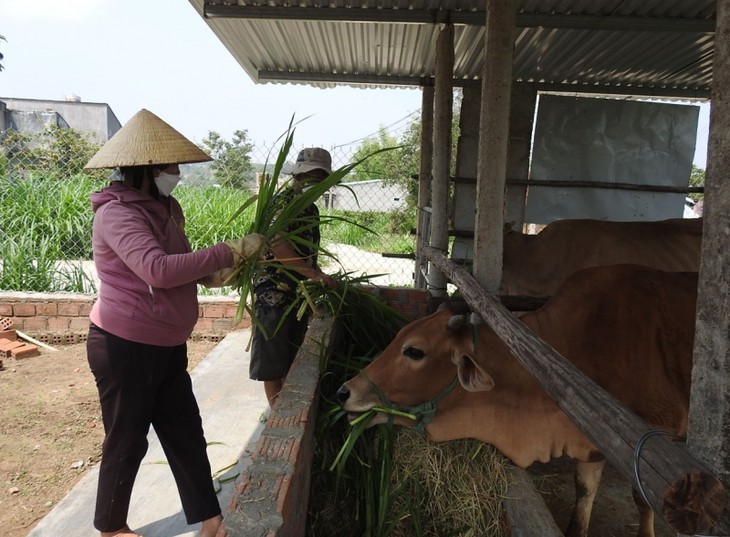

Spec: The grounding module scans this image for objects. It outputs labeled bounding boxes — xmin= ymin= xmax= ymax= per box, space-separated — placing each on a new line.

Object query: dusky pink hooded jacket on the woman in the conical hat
xmin=90 ymin=182 xmax=233 ymax=347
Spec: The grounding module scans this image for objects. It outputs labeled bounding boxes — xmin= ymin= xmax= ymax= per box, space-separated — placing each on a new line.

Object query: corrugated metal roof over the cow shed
xmin=189 ymin=0 xmax=715 ymax=97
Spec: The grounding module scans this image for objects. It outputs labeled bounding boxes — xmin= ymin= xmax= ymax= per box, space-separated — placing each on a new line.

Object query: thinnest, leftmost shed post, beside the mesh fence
xmin=414 ymin=86 xmax=434 ymax=289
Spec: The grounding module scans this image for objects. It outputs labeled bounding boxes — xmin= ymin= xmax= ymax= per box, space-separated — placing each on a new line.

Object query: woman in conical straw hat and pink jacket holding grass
xmin=86 ymin=110 xmax=263 ymax=537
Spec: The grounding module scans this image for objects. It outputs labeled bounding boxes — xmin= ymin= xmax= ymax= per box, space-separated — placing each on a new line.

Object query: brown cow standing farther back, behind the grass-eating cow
xmin=499 ymin=218 xmax=702 ymax=296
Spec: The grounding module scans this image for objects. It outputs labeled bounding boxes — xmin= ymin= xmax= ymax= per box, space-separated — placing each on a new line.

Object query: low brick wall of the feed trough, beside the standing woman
xmin=218 ymin=287 xmax=431 ymax=537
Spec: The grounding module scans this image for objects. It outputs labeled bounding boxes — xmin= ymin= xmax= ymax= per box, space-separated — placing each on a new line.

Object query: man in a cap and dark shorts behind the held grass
xmin=249 ymin=147 xmax=335 ymax=406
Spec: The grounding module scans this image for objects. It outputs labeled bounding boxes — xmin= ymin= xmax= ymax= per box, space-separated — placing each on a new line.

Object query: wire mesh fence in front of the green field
xmin=0 ymin=126 xmax=415 ymax=293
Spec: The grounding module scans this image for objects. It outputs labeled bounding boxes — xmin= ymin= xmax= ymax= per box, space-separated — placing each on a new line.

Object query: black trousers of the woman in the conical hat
xmin=86 ymin=324 xmax=221 ymax=531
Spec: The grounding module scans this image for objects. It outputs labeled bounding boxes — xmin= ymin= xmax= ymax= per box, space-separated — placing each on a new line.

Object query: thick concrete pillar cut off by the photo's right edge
xmin=687 ymin=2 xmax=730 ymax=526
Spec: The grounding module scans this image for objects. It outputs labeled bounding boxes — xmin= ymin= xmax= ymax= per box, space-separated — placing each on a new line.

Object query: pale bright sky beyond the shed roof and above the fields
xmin=0 ymin=0 xmax=709 ymax=168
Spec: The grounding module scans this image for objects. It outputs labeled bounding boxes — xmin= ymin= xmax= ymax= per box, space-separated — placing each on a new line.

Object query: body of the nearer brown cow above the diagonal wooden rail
xmin=522 ymin=265 xmax=697 ymax=433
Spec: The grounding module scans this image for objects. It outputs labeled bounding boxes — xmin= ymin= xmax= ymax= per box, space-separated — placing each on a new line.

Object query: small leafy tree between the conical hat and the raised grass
xmin=201 ymin=130 xmax=255 ymax=188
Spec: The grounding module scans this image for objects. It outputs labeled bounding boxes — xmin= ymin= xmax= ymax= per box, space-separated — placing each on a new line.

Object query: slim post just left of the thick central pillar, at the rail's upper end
xmin=428 ymin=24 xmax=454 ymax=297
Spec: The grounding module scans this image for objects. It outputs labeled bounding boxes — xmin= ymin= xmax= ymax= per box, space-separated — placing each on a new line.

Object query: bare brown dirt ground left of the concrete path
xmin=0 ymin=341 xmax=216 ymax=537
